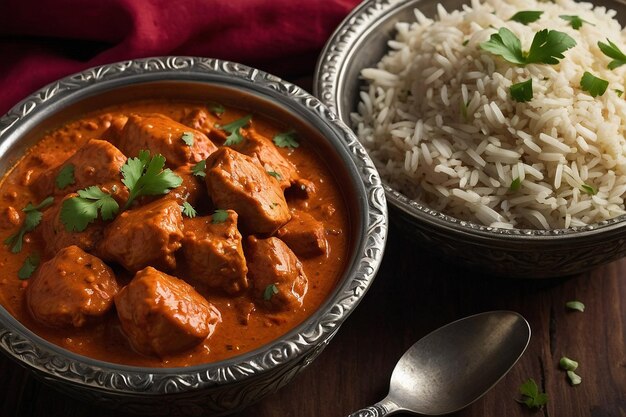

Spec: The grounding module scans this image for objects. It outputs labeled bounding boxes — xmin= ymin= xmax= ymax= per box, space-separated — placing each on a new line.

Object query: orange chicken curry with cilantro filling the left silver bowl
xmin=0 ymin=99 xmax=350 ymax=367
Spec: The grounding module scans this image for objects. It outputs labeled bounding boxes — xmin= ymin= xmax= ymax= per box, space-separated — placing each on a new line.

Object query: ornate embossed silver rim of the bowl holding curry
xmin=0 ymin=56 xmax=387 ymax=396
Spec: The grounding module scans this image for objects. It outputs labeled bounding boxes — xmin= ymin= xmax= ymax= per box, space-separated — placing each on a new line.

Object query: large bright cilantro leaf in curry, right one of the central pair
xmin=121 ymin=150 xmax=183 ymax=209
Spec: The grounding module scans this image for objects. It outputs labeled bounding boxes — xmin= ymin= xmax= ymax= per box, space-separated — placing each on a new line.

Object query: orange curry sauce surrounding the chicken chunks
xmin=0 ymin=99 xmax=350 ymax=367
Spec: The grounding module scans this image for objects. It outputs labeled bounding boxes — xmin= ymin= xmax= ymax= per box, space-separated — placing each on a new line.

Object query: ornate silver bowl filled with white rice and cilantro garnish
xmin=314 ymin=0 xmax=626 ymax=278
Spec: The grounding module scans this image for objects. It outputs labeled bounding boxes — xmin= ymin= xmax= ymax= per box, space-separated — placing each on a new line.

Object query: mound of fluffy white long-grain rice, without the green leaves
xmin=351 ymin=0 xmax=626 ymax=229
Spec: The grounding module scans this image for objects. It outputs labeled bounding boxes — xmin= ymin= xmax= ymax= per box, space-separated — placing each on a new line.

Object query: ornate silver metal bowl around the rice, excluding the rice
xmin=313 ymin=0 xmax=626 ymax=278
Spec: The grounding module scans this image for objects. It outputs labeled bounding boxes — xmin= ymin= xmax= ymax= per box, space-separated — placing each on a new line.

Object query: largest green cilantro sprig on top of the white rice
xmin=480 ymin=27 xmax=576 ymax=65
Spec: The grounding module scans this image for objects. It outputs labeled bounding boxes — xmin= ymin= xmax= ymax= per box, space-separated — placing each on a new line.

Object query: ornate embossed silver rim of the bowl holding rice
xmin=313 ymin=0 xmax=626 ymax=240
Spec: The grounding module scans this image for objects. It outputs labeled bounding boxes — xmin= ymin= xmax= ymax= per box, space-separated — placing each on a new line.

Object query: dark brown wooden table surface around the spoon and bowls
xmin=0 ymin=219 xmax=626 ymax=417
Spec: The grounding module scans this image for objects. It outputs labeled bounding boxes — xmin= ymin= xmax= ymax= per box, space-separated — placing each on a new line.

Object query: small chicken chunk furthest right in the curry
xmin=276 ymin=210 xmax=328 ymax=257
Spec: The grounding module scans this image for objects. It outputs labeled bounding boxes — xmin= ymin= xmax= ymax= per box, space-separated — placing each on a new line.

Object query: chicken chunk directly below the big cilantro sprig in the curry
xmin=98 ymin=198 xmax=183 ymax=272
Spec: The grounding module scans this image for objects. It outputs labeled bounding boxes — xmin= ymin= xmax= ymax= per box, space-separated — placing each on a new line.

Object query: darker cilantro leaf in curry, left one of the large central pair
xmin=60 ymin=185 xmax=120 ymax=232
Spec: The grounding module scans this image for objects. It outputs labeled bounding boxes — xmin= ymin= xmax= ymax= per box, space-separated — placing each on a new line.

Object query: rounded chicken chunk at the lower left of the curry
xmin=26 ymin=246 xmax=119 ymax=327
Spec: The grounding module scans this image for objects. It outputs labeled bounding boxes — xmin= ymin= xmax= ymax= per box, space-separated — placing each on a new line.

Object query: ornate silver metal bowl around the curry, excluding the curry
xmin=0 ymin=57 xmax=387 ymax=415
